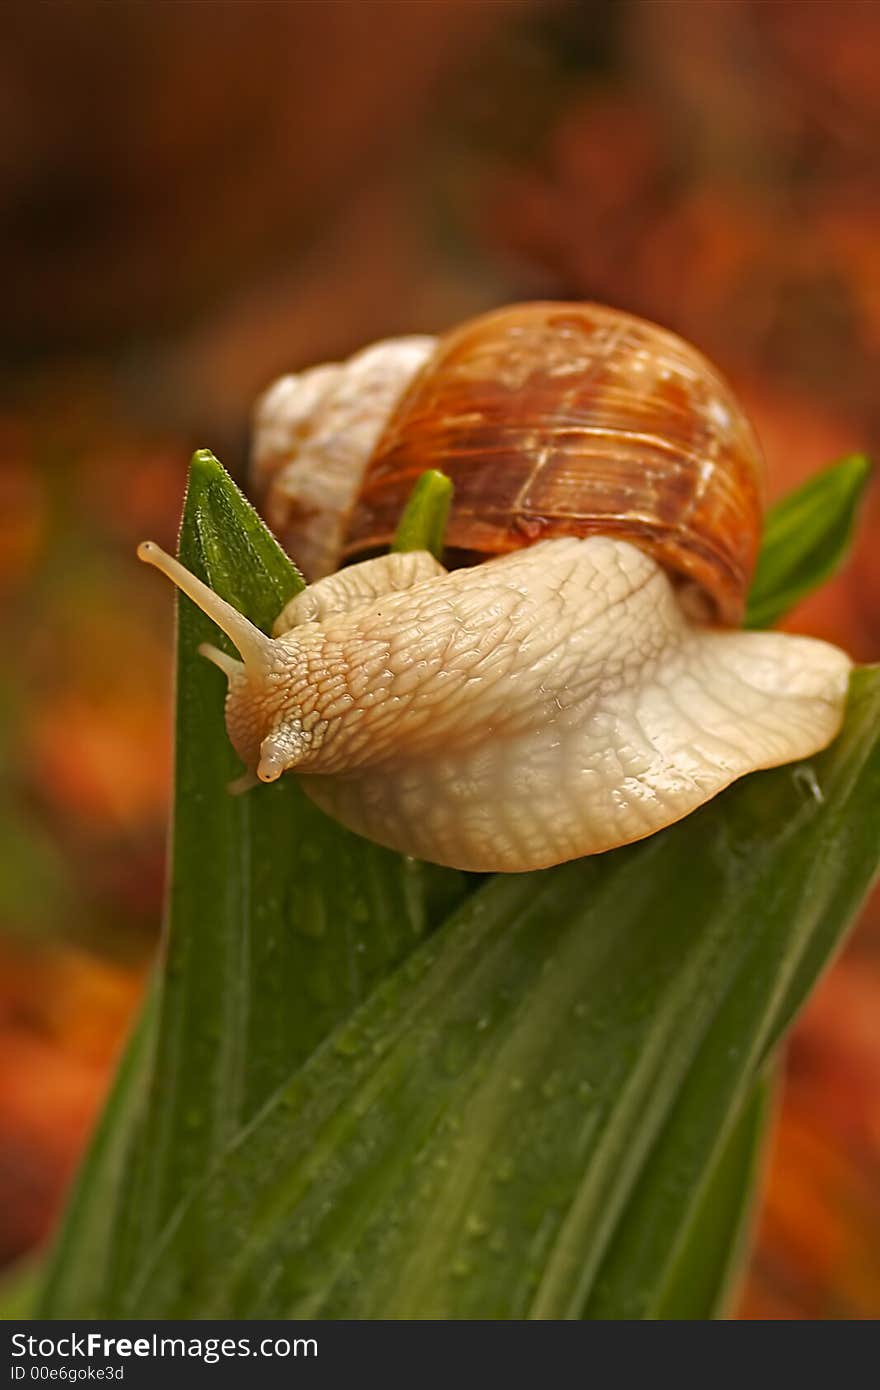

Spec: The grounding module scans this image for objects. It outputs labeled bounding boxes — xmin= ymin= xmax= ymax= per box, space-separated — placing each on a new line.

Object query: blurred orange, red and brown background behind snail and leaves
xmin=0 ymin=0 xmax=880 ymax=1319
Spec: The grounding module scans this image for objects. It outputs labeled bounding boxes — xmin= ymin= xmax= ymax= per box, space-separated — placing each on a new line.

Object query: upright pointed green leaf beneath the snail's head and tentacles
xmin=43 ymin=450 xmax=467 ymax=1318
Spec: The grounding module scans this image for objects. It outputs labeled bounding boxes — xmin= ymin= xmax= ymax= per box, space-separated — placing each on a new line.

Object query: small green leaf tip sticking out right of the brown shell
xmin=745 ymin=453 xmax=870 ymax=627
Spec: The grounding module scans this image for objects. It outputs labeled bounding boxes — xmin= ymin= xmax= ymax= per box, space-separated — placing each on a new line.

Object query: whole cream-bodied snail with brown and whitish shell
xmin=139 ymin=303 xmax=849 ymax=872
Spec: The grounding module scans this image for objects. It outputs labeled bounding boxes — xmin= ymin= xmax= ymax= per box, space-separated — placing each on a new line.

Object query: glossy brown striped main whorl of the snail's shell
xmin=343 ymin=303 xmax=763 ymax=624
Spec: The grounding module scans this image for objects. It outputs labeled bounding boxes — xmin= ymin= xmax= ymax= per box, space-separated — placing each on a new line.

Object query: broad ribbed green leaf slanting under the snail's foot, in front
xmin=106 ymin=669 xmax=880 ymax=1318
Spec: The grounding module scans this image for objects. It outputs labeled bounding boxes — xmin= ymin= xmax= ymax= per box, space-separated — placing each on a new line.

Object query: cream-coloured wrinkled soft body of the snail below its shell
xmin=204 ymin=537 xmax=849 ymax=872
